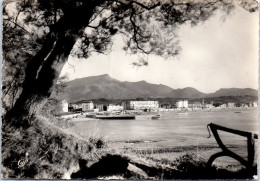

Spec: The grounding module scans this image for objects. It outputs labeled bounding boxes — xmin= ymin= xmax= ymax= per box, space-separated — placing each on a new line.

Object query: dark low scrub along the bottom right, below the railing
xmin=121 ymin=151 xmax=257 ymax=180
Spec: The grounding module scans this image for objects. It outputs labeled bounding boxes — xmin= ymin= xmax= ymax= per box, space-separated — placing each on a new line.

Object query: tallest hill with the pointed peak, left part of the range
xmin=68 ymin=74 xmax=175 ymax=102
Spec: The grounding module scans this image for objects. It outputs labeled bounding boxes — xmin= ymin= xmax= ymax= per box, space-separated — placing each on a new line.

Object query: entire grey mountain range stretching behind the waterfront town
xmin=65 ymin=74 xmax=258 ymax=102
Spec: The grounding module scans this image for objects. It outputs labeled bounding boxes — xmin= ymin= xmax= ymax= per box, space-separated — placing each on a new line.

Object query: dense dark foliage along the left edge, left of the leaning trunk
xmin=2 ymin=2 xmax=40 ymax=110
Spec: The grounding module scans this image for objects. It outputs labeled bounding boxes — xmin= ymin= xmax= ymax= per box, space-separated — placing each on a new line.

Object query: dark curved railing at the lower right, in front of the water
xmin=207 ymin=123 xmax=258 ymax=168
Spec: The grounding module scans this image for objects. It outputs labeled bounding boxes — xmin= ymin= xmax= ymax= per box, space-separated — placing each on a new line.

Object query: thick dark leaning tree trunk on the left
xmin=4 ymin=3 xmax=97 ymax=126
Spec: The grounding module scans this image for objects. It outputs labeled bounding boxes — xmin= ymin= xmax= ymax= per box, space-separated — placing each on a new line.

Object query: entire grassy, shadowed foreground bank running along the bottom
xmin=2 ymin=116 xmax=257 ymax=179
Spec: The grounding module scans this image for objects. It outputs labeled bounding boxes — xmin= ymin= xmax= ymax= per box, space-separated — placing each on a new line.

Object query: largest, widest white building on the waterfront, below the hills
xmin=130 ymin=101 xmax=159 ymax=110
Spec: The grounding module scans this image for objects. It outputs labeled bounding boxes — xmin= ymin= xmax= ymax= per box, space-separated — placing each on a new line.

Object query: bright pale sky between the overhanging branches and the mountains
xmin=61 ymin=7 xmax=258 ymax=93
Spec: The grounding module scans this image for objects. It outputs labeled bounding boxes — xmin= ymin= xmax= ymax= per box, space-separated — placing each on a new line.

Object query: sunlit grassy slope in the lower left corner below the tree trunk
xmin=2 ymin=116 xmax=107 ymax=179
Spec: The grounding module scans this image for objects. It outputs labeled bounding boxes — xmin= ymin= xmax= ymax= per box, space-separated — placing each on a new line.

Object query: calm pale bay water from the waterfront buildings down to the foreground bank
xmin=69 ymin=109 xmax=258 ymax=166
